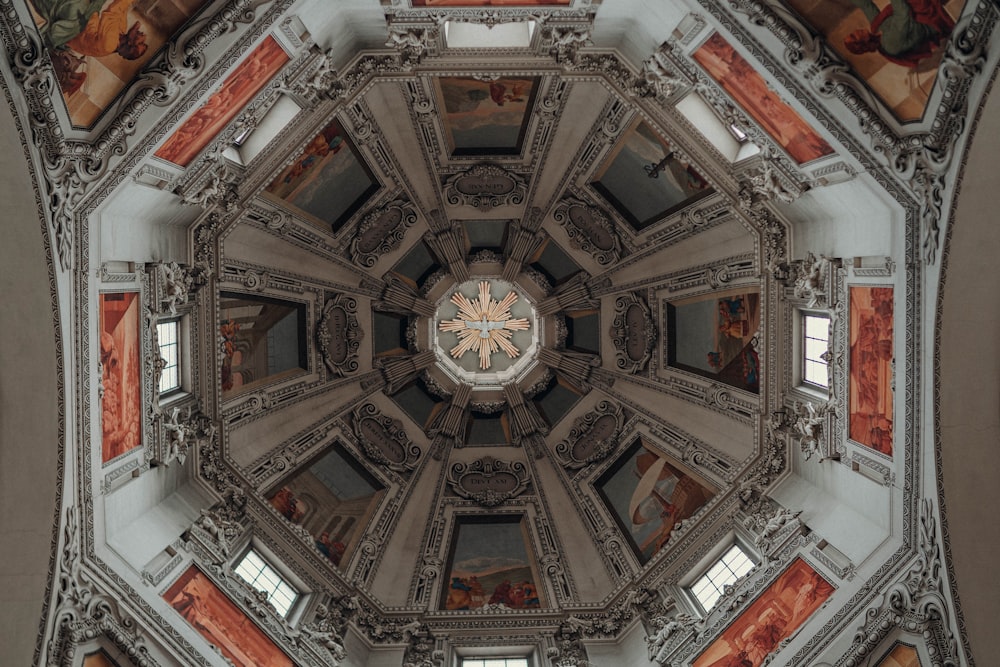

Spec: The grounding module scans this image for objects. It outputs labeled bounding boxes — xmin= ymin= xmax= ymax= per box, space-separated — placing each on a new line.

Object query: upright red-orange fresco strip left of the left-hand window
xmin=100 ymin=292 xmax=142 ymax=463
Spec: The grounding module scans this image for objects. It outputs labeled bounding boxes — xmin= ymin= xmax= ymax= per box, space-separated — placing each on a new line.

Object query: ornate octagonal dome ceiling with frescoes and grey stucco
xmin=4 ymin=0 xmax=995 ymax=667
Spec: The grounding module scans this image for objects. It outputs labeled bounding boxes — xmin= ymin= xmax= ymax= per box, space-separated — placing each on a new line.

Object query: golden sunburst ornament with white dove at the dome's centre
xmin=438 ymin=280 xmax=529 ymax=371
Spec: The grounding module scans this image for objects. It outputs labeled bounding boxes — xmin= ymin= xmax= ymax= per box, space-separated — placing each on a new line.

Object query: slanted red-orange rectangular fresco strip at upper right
xmin=692 ymin=33 xmax=833 ymax=164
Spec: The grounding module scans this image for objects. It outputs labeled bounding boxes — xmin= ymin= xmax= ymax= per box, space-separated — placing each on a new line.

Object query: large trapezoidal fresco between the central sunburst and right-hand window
xmin=667 ymin=292 xmax=760 ymax=393
